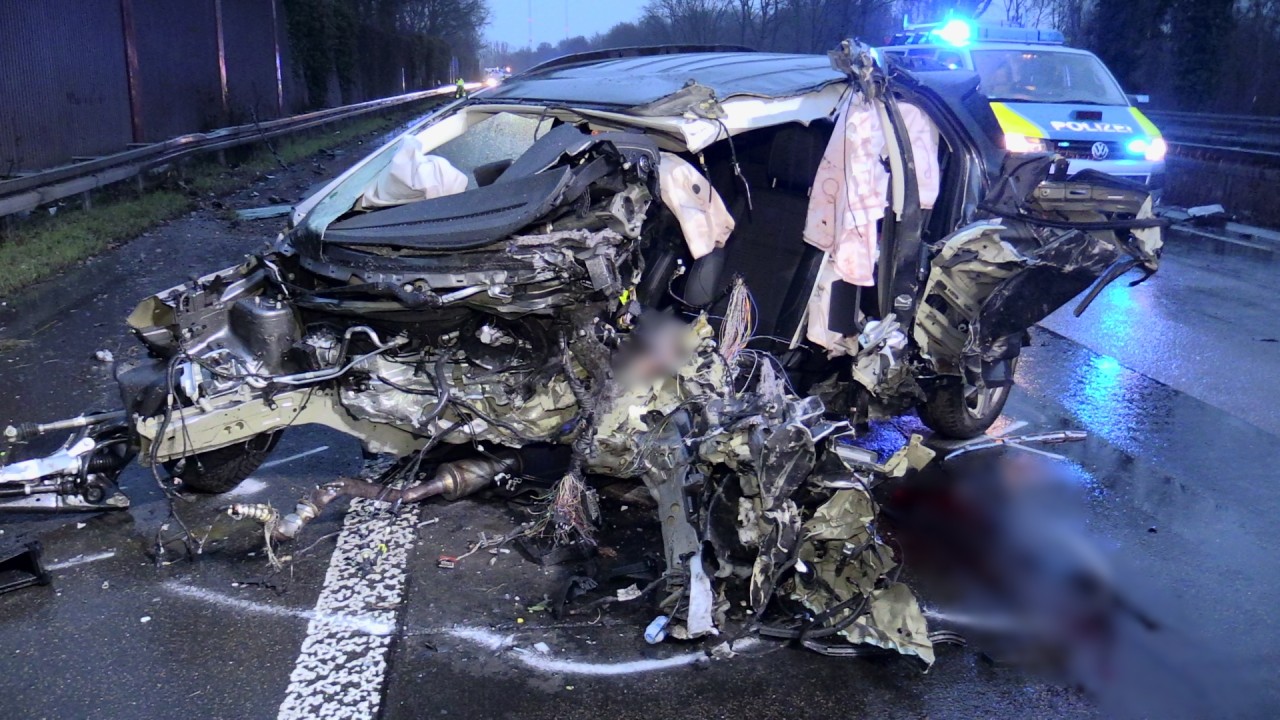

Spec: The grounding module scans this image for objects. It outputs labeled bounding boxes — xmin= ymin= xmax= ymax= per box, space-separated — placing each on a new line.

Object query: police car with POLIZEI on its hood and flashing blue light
xmin=879 ymin=19 xmax=1167 ymax=187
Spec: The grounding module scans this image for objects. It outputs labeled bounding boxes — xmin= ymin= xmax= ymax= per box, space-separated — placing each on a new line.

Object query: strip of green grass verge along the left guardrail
xmin=0 ymin=108 xmax=437 ymax=297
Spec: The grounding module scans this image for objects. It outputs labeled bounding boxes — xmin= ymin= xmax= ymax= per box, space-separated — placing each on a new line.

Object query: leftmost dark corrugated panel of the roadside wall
xmin=0 ymin=0 xmax=132 ymax=176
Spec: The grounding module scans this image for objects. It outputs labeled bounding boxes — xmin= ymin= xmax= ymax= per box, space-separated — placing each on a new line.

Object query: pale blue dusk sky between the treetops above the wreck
xmin=484 ymin=0 xmax=645 ymax=47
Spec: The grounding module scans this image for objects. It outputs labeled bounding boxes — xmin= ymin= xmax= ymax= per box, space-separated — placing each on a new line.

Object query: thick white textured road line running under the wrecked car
xmin=279 ymin=489 xmax=421 ymax=720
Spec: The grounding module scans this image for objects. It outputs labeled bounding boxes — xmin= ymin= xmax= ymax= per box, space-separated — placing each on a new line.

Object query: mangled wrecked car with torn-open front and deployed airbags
xmin=0 ymin=44 xmax=1162 ymax=662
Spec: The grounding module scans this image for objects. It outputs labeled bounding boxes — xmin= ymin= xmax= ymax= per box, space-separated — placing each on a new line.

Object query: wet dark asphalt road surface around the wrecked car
xmin=0 ymin=160 xmax=1280 ymax=719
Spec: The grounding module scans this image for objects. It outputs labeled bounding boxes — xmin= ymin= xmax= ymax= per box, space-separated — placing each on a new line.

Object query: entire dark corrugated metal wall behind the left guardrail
xmin=0 ymin=0 xmax=448 ymax=178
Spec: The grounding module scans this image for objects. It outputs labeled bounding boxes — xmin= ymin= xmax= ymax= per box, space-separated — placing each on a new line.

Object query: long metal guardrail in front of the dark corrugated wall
xmin=0 ymin=85 xmax=463 ymax=218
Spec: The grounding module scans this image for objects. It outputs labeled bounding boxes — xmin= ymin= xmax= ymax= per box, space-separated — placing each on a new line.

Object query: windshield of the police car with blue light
xmin=972 ymin=49 xmax=1129 ymax=105
